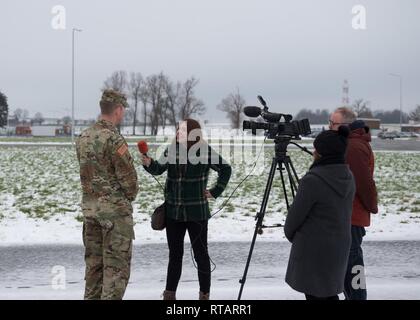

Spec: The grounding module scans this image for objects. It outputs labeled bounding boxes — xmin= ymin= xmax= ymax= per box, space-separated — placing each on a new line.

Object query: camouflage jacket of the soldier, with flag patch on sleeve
xmin=76 ymin=120 xmax=138 ymax=219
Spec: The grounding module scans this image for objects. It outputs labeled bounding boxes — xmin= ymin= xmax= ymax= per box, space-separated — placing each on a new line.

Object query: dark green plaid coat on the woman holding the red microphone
xmin=144 ymin=143 xmax=232 ymax=221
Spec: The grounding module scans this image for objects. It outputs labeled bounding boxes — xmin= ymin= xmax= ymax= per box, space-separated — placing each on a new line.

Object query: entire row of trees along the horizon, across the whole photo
xmin=0 ymin=84 xmax=420 ymax=135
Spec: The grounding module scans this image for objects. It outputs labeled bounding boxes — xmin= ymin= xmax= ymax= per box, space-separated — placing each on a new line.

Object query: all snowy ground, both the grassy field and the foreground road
xmin=0 ymin=141 xmax=420 ymax=300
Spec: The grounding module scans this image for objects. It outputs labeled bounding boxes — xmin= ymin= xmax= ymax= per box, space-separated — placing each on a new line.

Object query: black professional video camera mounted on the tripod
xmin=243 ymin=96 xmax=311 ymax=139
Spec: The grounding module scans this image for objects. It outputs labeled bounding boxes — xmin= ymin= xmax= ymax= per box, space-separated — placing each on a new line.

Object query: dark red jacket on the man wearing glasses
xmin=346 ymin=128 xmax=378 ymax=227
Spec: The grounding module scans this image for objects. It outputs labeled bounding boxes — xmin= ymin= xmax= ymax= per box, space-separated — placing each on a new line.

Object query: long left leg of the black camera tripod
xmin=238 ymin=158 xmax=277 ymax=300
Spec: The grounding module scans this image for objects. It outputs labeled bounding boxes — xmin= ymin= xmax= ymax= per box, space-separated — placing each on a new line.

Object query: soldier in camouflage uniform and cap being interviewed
xmin=76 ymin=90 xmax=138 ymax=299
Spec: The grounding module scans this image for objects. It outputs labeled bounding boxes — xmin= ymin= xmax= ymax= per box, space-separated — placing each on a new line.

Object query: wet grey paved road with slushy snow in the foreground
xmin=0 ymin=241 xmax=420 ymax=299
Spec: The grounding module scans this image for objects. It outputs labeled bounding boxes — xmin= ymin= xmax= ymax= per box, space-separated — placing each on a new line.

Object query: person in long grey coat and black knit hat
xmin=284 ymin=126 xmax=355 ymax=300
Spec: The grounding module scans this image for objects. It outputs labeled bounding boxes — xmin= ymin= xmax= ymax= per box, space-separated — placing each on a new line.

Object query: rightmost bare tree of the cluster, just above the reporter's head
xmin=178 ymin=77 xmax=206 ymax=120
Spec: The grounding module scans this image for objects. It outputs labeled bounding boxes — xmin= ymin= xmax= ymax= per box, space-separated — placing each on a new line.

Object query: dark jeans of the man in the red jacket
xmin=344 ymin=226 xmax=367 ymax=300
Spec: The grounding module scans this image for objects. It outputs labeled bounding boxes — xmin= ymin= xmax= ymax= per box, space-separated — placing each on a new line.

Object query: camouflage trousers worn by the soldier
xmin=83 ymin=216 xmax=134 ymax=300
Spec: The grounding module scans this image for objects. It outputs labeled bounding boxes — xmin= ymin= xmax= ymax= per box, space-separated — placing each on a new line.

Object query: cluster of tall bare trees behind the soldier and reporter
xmin=102 ymin=70 xmax=206 ymax=135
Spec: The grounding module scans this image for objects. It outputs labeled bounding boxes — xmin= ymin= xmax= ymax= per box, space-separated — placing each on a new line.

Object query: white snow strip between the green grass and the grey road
xmin=0 ymin=201 xmax=420 ymax=246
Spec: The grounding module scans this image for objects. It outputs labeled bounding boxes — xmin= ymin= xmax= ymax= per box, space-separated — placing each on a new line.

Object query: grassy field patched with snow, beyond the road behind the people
xmin=0 ymin=142 xmax=420 ymax=246
